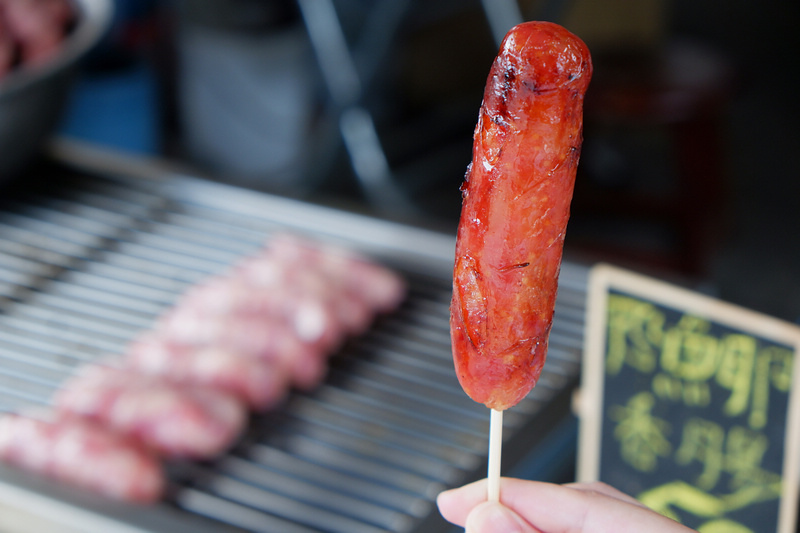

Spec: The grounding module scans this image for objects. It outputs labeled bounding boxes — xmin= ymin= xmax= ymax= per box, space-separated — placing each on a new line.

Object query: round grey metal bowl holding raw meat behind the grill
xmin=0 ymin=0 xmax=112 ymax=184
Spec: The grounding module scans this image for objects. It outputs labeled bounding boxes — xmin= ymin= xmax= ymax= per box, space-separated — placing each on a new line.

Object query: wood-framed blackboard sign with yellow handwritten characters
xmin=578 ymin=265 xmax=800 ymax=533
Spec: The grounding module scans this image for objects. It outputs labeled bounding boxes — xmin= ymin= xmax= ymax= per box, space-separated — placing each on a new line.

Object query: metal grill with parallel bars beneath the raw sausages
xmin=0 ymin=145 xmax=586 ymax=533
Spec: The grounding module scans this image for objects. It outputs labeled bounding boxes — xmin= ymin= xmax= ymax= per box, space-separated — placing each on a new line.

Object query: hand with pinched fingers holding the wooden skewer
xmin=437 ymin=478 xmax=693 ymax=533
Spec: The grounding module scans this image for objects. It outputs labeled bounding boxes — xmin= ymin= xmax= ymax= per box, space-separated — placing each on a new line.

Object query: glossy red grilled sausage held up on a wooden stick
xmin=450 ymin=22 xmax=592 ymax=410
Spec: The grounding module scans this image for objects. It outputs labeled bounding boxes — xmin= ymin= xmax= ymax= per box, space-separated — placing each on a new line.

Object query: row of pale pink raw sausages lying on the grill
xmin=0 ymin=235 xmax=406 ymax=502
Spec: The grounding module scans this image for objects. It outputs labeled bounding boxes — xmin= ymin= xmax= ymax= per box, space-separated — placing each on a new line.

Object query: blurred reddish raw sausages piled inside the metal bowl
xmin=0 ymin=0 xmax=75 ymax=79
